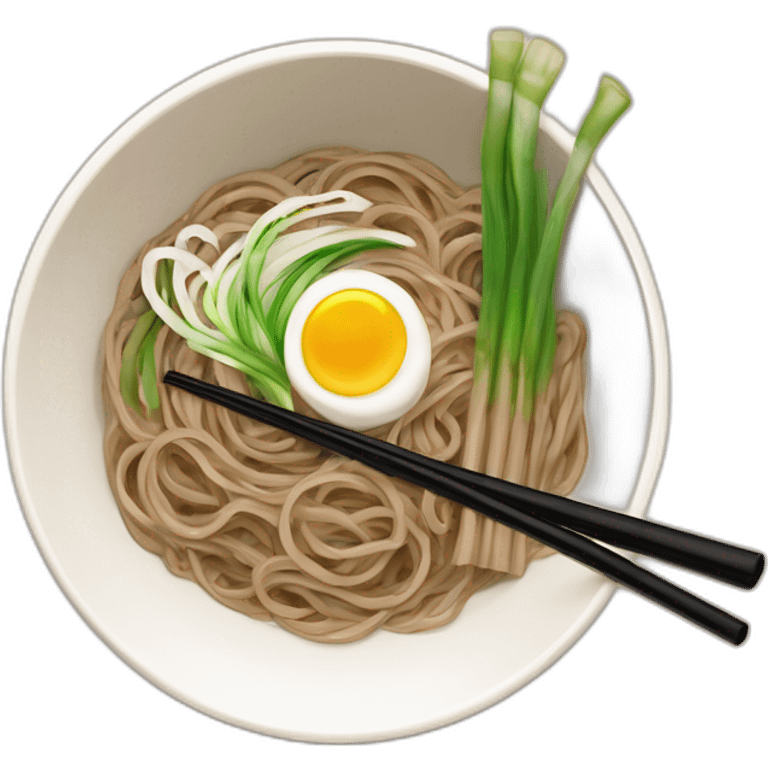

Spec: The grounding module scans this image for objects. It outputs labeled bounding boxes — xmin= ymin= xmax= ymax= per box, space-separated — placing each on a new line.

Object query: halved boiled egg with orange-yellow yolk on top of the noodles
xmin=284 ymin=269 xmax=432 ymax=431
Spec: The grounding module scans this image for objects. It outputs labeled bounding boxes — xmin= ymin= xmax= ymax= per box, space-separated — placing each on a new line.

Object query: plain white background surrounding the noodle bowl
xmin=3 ymin=12 xmax=768 ymax=760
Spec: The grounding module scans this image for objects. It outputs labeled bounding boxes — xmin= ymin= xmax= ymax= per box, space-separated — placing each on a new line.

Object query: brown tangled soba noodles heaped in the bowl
xmin=97 ymin=147 xmax=587 ymax=642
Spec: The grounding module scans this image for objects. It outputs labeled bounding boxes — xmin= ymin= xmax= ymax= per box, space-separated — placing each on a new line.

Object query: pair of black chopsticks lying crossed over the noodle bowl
xmin=163 ymin=371 xmax=766 ymax=647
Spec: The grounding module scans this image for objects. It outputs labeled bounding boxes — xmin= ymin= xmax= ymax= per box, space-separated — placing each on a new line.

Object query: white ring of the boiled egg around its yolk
xmin=283 ymin=269 xmax=432 ymax=432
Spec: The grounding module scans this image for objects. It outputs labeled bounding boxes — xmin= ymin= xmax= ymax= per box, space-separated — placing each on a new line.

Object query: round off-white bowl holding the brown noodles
xmin=4 ymin=40 xmax=669 ymax=742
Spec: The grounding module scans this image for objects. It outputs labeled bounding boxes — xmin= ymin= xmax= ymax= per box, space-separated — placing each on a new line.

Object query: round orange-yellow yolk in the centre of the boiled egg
xmin=301 ymin=288 xmax=407 ymax=397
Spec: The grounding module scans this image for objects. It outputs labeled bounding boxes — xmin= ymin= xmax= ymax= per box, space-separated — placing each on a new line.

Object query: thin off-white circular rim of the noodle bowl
xmin=3 ymin=38 xmax=671 ymax=743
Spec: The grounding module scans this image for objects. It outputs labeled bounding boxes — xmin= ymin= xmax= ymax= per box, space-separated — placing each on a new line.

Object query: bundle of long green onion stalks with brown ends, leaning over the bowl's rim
xmin=454 ymin=29 xmax=632 ymax=563
